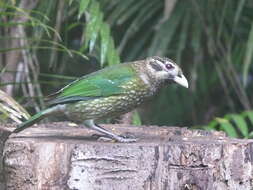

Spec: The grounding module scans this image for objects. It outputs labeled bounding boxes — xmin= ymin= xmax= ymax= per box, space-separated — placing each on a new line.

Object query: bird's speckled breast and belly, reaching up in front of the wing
xmin=63 ymin=79 xmax=153 ymax=122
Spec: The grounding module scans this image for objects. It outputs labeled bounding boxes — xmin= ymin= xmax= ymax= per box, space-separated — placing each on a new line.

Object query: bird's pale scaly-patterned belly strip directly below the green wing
xmin=65 ymin=93 xmax=147 ymax=122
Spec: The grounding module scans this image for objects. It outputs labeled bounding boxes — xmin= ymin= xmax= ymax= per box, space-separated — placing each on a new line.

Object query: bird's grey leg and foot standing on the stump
xmin=84 ymin=120 xmax=137 ymax=143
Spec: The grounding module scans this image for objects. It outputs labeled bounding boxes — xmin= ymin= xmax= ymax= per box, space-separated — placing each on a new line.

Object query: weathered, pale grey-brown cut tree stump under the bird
xmin=0 ymin=122 xmax=253 ymax=190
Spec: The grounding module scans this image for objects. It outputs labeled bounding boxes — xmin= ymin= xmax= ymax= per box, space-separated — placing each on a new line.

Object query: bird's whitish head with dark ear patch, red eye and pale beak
xmin=146 ymin=56 xmax=188 ymax=88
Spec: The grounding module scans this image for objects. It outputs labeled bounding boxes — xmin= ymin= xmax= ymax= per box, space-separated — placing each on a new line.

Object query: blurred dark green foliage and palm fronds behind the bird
xmin=0 ymin=0 xmax=253 ymax=137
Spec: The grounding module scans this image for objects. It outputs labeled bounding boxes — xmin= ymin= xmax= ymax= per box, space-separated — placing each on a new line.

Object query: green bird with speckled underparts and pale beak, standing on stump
xmin=13 ymin=56 xmax=188 ymax=142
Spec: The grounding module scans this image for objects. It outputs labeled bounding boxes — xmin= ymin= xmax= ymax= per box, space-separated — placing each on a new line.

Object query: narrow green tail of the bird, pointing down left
xmin=12 ymin=106 xmax=63 ymax=133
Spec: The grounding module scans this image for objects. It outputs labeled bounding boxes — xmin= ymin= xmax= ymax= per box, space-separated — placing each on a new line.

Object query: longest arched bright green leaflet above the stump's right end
xmin=225 ymin=114 xmax=249 ymax=137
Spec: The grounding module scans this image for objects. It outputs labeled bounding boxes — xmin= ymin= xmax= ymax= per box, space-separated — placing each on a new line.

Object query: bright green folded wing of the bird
xmin=49 ymin=64 xmax=137 ymax=105
